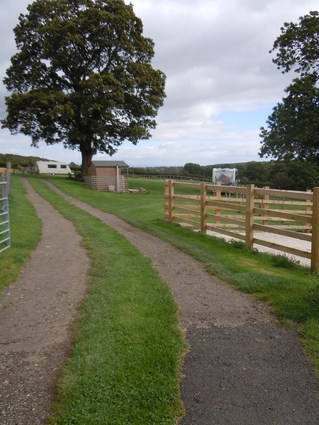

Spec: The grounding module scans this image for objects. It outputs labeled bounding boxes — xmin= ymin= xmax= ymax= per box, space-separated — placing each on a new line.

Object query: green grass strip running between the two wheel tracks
xmin=32 ymin=179 xmax=185 ymax=425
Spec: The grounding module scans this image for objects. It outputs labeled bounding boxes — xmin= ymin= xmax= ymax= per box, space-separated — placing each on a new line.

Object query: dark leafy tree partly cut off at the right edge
xmin=260 ymin=12 xmax=319 ymax=161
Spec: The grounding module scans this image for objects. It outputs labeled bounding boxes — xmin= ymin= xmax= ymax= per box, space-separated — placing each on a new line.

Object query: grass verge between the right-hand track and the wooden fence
xmin=47 ymin=179 xmax=319 ymax=371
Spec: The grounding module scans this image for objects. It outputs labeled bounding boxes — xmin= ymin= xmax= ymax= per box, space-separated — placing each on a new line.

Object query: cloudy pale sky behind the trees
xmin=0 ymin=0 xmax=318 ymax=166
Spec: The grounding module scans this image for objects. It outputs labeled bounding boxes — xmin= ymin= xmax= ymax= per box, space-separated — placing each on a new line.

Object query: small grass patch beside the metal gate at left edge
xmin=0 ymin=176 xmax=42 ymax=292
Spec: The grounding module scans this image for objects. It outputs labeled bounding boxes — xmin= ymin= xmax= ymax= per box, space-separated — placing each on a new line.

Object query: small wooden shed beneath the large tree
xmin=84 ymin=161 xmax=129 ymax=192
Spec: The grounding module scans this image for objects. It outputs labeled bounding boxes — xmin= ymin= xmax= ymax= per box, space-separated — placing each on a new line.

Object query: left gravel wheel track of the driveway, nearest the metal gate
xmin=0 ymin=181 xmax=89 ymax=425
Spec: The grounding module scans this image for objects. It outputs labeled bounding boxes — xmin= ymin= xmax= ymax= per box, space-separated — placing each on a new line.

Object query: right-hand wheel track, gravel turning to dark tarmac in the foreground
xmin=47 ymin=183 xmax=319 ymax=425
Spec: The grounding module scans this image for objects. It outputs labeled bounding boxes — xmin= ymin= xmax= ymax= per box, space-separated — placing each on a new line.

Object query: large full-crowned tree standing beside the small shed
xmin=2 ymin=0 xmax=165 ymax=173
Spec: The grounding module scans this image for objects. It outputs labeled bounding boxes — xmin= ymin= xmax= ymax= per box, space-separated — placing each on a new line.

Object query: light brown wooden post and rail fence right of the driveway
xmin=165 ymin=180 xmax=319 ymax=272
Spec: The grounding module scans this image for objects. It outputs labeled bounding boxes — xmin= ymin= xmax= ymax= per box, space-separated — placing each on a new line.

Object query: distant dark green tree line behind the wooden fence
xmin=130 ymin=160 xmax=319 ymax=190
